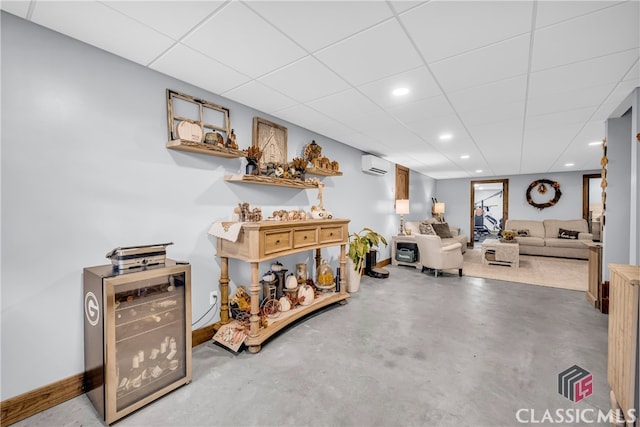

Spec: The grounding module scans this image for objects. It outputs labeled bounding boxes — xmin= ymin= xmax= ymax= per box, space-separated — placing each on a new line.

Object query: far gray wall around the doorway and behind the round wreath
xmin=436 ymin=171 xmax=599 ymax=239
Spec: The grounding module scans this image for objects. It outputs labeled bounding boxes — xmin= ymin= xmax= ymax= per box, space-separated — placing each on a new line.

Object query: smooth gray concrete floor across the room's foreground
xmin=15 ymin=266 xmax=609 ymax=427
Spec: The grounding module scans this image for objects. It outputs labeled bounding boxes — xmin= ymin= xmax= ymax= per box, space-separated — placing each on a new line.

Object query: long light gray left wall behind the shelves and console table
xmin=0 ymin=12 xmax=434 ymax=400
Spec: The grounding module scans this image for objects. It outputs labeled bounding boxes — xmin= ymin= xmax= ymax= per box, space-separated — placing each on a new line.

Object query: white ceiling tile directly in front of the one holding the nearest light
xmin=315 ymin=20 xmax=422 ymax=86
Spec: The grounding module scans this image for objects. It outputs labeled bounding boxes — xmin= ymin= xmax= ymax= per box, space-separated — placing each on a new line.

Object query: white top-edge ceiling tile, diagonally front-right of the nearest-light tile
xmin=400 ymin=1 xmax=532 ymax=63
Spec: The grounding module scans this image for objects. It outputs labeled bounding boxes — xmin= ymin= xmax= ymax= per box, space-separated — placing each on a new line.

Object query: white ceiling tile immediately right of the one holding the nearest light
xmin=430 ymin=35 xmax=529 ymax=92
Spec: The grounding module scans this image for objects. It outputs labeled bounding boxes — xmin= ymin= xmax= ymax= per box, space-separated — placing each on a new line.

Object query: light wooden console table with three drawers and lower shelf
xmin=216 ymin=219 xmax=350 ymax=353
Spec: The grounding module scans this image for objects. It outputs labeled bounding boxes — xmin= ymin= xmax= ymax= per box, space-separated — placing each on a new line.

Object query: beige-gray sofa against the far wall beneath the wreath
xmin=504 ymin=219 xmax=593 ymax=259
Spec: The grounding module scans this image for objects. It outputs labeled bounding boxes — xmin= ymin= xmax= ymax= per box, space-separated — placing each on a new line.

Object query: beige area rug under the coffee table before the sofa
xmin=462 ymin=249 xmax=589 ymax=291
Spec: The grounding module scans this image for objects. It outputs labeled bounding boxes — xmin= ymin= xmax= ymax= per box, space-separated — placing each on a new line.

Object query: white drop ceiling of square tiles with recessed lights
xmin=2 ymin=0 xmax=640 ymax=179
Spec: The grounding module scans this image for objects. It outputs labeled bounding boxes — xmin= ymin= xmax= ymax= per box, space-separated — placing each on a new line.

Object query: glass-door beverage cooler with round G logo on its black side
xmin=83 ymin=259 xmax=191 ymax=424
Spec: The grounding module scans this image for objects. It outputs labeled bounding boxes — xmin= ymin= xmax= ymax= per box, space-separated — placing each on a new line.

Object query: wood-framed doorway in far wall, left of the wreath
xmin=469 ymin=179 xmax=509 ymax=247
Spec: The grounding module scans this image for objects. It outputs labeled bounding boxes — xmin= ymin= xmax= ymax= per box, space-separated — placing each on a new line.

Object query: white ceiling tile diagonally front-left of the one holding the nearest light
xmin=258 ymin=56 xmax=350 ymax=102
